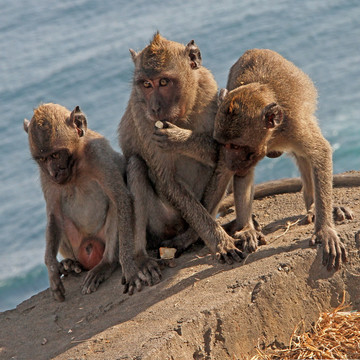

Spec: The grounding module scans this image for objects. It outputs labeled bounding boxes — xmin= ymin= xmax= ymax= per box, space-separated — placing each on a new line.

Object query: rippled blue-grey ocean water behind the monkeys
xmin=0 ymin=0 xmax=360 ymax=311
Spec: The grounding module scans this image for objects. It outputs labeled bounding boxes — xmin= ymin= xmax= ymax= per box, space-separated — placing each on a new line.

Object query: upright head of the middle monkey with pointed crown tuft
xmin=130 ymin=33 xmax=201 ymax=123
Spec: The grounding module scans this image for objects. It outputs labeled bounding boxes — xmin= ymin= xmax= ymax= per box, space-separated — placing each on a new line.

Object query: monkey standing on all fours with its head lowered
xmin=214 ymin=49 xmax=351 ymax=269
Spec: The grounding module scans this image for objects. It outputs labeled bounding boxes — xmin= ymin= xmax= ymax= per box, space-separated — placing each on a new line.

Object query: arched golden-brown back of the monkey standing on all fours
xmin=227 ymin=49 xmax=317 ymax=116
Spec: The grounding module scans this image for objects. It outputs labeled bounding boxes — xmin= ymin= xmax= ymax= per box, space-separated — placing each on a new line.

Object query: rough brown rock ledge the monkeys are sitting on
xmin=0 ymin=172 xmax=360 ymax=360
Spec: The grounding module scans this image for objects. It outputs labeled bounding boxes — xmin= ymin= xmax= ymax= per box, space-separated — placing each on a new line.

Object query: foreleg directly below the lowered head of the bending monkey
xmin=231 ymin=168 xmax=266 ymax=252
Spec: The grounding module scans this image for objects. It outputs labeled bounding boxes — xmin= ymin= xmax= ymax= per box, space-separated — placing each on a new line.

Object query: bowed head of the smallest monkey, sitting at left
xmin=24 ymin=104 xmax=87 ymax=184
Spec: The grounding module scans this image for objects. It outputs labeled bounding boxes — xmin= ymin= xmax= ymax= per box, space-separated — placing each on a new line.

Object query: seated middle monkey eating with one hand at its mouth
xmin=119 ymin=33 xmax=241 ymax=282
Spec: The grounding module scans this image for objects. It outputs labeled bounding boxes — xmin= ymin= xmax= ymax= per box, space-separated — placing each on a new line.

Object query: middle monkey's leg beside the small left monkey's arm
xmin=127 ymin=156 xmax=167 ymax=285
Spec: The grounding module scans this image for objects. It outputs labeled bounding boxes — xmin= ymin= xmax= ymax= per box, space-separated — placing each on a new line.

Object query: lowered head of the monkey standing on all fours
xmin=214 ymin=83 xmax=283 ymax=176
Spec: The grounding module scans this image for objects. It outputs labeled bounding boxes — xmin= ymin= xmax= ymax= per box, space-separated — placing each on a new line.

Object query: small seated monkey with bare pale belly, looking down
xmin=24 ymin=104 xmax=146 ymax=301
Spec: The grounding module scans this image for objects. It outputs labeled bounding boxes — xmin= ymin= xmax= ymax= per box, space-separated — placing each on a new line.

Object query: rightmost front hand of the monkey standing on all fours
xmin=310 ymin=226 xmax=347 ymax=271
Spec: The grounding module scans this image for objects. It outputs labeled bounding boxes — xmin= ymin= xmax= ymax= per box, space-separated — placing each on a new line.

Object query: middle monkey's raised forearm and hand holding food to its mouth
xmin=153 ymin=122 xmax=219 ymax=167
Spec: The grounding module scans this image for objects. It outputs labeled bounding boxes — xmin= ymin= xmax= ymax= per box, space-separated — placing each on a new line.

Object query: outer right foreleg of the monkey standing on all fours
xmin=306 ymin=132 xmax=347 ymax=270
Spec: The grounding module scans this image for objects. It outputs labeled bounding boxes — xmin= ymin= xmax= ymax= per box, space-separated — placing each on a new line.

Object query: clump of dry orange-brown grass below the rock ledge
xmin=251 ymin=296 xmax=360 ymax=360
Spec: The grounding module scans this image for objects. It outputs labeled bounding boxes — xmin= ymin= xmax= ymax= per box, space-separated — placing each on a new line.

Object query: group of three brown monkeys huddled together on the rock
xmin=24 ymin=33 xmax=353 ymax=301
